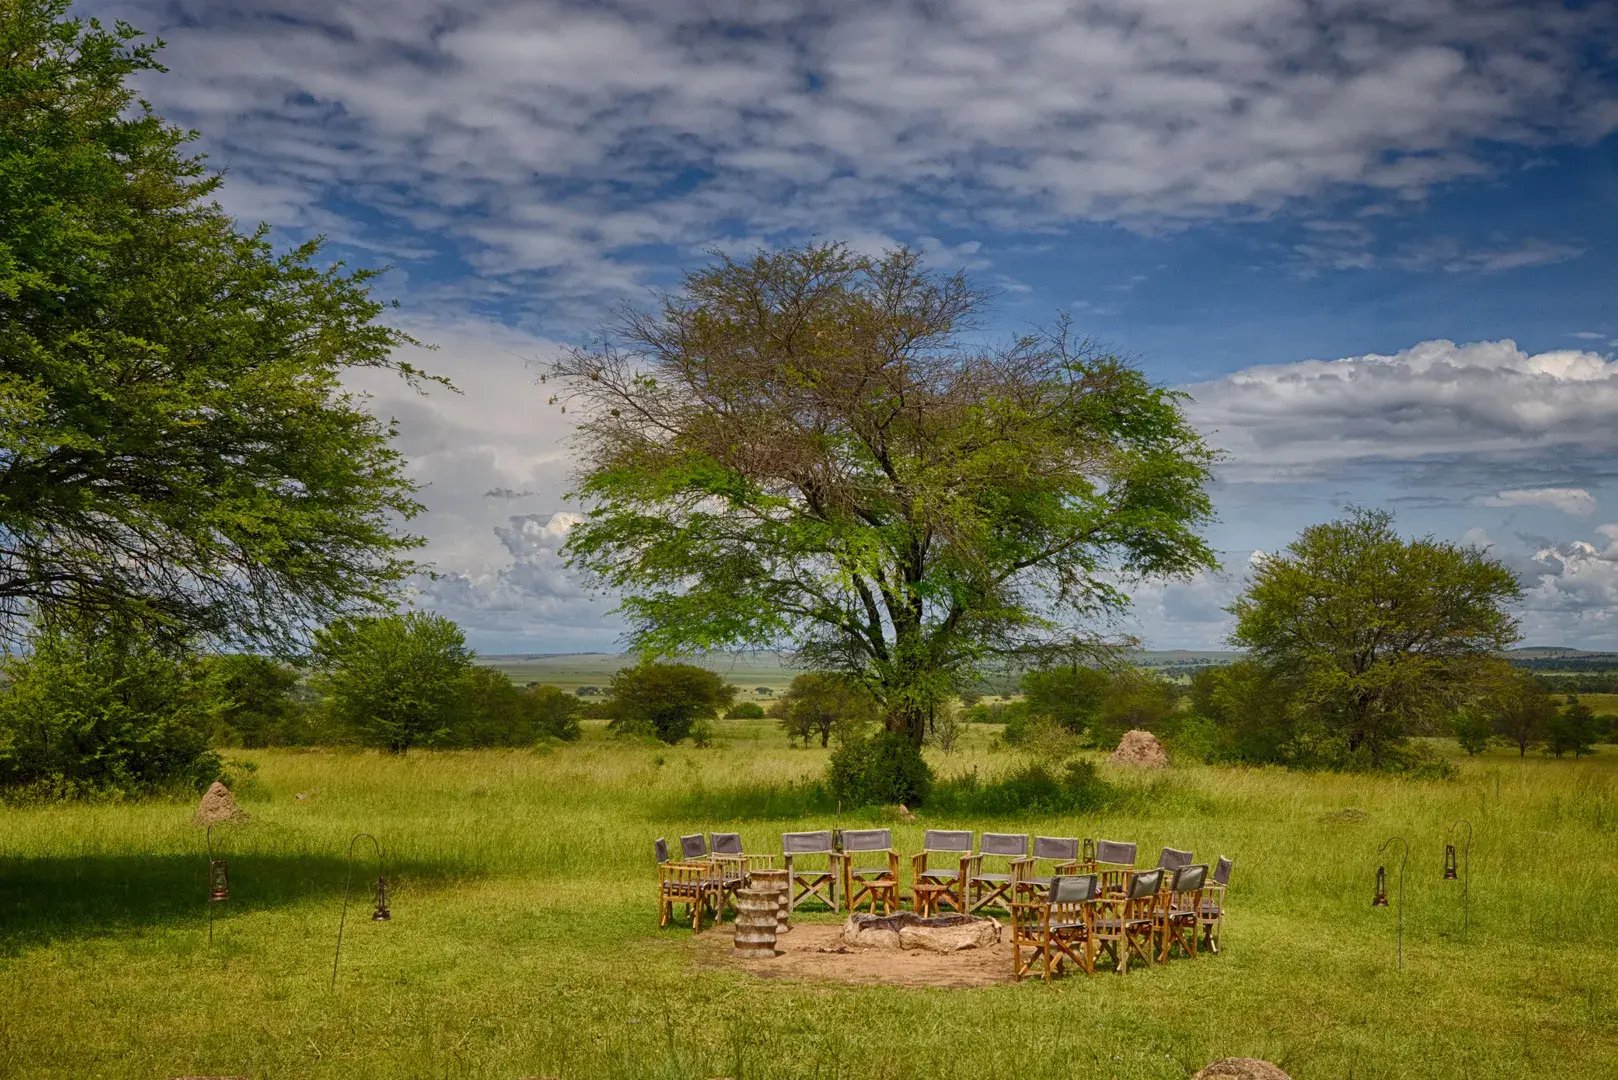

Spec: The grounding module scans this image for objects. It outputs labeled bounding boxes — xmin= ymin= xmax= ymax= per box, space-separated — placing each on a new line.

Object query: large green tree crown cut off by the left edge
xmin=0 ymin=0 xmax=436 ymax=648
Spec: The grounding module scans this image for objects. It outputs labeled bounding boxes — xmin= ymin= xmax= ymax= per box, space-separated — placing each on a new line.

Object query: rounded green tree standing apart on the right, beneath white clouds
xmin=1230 ymin=510 xmax=1519 ymax=767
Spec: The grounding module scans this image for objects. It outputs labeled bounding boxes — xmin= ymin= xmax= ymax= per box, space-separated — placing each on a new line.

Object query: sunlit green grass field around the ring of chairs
xmin=0 ymin=722 xmax=1618 ymax=1080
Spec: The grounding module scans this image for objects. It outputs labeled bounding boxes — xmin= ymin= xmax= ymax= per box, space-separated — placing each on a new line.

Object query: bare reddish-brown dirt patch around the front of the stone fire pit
xmin=696 ymin=923 xmax=1011 ymax=988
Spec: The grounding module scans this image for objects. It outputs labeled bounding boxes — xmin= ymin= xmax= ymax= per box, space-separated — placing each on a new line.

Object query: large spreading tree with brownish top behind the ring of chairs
xmin=547 ymin=244 xmax=1214 ymax=743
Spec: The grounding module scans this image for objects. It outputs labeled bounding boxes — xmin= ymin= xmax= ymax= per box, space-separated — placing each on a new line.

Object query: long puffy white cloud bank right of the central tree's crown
xmin=1189 ymin=340 xmax=1618 ymax=482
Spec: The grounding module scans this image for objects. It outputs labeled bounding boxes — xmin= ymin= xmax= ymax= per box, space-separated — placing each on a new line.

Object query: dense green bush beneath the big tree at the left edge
xmin=0 ymin=622 xmax=220 ymax=800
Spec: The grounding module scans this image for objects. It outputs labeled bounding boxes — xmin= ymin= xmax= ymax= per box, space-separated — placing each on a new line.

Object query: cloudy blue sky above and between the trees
xmin=104 ymin=0 xmax=1618 ymax=651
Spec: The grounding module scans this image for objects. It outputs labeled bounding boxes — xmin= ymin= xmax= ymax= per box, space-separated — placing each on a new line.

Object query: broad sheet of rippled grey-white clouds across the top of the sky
xmin=92 ymin=0 xmax=1618 ymax=314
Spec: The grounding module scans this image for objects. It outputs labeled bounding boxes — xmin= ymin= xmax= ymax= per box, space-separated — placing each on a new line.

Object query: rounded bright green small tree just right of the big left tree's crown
xmin=314 ymin=612 xmax=472 ymax=753
